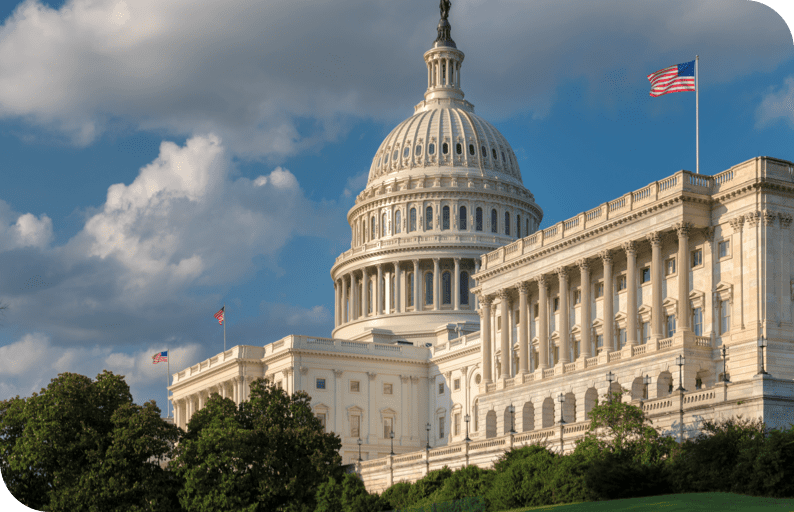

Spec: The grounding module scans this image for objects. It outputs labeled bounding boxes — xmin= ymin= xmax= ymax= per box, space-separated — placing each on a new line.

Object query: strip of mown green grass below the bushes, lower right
xmin=503 ymin=492 xmax=794 ymax=512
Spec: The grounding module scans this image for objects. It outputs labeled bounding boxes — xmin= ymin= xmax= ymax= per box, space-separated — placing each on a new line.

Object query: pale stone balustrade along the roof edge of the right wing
xmin=474 ymin=157 xmax=794 ymax=278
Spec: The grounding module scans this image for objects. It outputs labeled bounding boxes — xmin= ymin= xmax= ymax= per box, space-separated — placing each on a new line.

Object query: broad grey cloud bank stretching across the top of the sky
xmin=0 ymin=0 xmax=792 ymax=158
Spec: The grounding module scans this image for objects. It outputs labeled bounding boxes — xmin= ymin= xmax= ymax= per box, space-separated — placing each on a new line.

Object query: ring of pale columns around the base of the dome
xmin=334 ymin=258 xmax=480 ymax=327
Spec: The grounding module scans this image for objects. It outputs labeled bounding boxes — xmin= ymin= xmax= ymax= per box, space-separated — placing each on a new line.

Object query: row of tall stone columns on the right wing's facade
xmin=478 ymin=223 xmax=692 ymax=384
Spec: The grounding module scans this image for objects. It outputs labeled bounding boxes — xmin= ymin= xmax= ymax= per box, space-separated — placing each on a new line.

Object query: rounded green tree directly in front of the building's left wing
xmin=170 ymin=379 xmax=341 ymax=512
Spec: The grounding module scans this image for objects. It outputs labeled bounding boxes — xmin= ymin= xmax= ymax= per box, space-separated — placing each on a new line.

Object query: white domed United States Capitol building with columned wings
xmin=169 ymin=5 xmax=794 ymax=491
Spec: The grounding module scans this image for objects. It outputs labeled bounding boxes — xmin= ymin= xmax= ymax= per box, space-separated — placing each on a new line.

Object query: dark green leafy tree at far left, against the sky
xmin=0 ymin=371 xmax=180 ymax=511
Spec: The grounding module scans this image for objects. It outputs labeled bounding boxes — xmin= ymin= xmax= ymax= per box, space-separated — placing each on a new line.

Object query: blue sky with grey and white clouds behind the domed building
xmin=0 ymin=0 xmax=794 ymax=410
